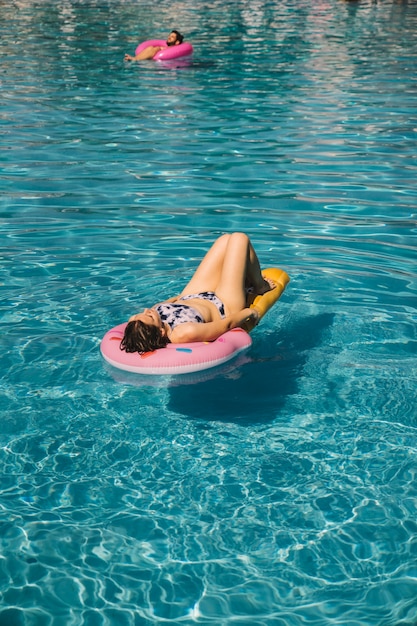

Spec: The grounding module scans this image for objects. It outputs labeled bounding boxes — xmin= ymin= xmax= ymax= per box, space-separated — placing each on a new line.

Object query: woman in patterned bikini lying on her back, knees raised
xmin=120 ymin=233 xmax=275 ymax=353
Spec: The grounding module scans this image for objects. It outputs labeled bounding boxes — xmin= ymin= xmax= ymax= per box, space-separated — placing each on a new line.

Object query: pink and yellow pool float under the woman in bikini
xmin=100 ymin=268 xmax=290 ymax=375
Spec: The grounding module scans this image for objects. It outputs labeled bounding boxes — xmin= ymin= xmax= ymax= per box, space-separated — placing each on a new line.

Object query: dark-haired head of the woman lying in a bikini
xmin=120 ymin=309 xmax=169 ymax=353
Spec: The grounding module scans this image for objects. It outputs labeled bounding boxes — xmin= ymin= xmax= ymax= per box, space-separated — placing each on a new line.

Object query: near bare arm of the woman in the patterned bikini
xmin=169 ymin=309 xmax=259 ymax=343
